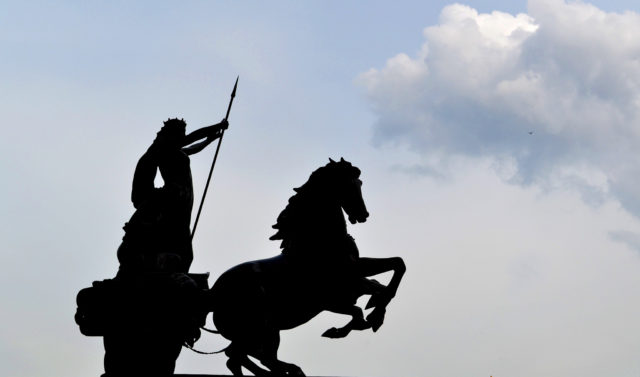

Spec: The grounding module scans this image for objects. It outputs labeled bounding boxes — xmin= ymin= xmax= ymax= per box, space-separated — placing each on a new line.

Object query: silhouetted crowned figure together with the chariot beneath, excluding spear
xmin=76 ymin=119 xmax=228 ymax=376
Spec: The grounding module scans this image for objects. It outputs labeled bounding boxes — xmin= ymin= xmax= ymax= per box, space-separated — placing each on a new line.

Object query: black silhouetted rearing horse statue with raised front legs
xmin=208 ymin=159 xmax=405 ymax=376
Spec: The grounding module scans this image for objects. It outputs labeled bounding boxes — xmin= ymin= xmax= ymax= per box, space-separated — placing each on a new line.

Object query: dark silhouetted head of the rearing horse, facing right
xmin=327 ymin=158 xmax=369 ymax=224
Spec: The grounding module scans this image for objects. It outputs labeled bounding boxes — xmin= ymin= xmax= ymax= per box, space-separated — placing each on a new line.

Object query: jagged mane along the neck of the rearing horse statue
xmin=269 ymin=159 xmax=360 ymax=249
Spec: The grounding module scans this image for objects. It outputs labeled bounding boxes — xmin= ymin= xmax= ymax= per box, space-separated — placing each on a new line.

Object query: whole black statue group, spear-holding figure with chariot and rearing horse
xmin=75 ymin=79 xmax=405 ymax=377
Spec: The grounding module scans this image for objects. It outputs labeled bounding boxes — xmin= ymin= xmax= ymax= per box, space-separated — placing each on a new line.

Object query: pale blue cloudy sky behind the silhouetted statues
xmin=0 ymin=0 xmax=640 ymax=377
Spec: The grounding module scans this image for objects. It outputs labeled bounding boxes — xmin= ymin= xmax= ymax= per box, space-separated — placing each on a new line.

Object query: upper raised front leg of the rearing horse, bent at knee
xmin=358 ymin=257 xmax=407 ymax=331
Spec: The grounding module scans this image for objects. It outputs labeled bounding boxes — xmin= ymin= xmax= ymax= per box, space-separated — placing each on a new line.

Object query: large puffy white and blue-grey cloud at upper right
xmin=357 ymin=0 xmax=640 ymax=215
